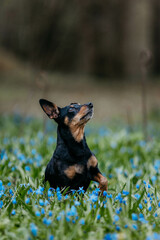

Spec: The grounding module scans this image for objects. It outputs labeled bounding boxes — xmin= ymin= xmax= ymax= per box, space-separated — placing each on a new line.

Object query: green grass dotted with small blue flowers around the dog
xmin=0 ymin=115 xmax=160 ymax=240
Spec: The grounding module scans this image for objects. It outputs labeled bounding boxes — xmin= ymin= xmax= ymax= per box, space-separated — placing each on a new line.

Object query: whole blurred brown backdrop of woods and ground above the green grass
xmin=0 ymin=0 xmax=160 ymax=122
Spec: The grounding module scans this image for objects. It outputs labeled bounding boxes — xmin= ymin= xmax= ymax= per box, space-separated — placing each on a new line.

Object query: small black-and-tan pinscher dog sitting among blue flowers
xmin=39 ymin=99 xmax=107 ymax=192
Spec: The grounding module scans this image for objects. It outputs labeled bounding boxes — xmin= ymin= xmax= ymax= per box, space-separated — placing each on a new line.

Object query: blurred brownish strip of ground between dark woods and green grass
xmin=0 ymin=47 xmax=160 ymax=123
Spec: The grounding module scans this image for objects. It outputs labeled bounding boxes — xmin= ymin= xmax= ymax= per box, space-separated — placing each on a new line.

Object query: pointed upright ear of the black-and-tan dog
xmin=39 ymin=99 xmax=59 ymax=119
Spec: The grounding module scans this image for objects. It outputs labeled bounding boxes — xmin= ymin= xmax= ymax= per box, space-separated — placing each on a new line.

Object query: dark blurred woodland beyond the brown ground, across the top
xmin=0 ymin=0 xmax=156 ymax=77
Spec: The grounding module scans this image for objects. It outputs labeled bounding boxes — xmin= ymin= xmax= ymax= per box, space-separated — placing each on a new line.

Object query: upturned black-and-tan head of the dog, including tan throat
xmin=39 ymin=99 xmax=93 ymax=141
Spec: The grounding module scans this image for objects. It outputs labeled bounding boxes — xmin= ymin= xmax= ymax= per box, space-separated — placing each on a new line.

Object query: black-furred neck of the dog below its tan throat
xmin=57 ymin=126 xmax=91 ymax=158
